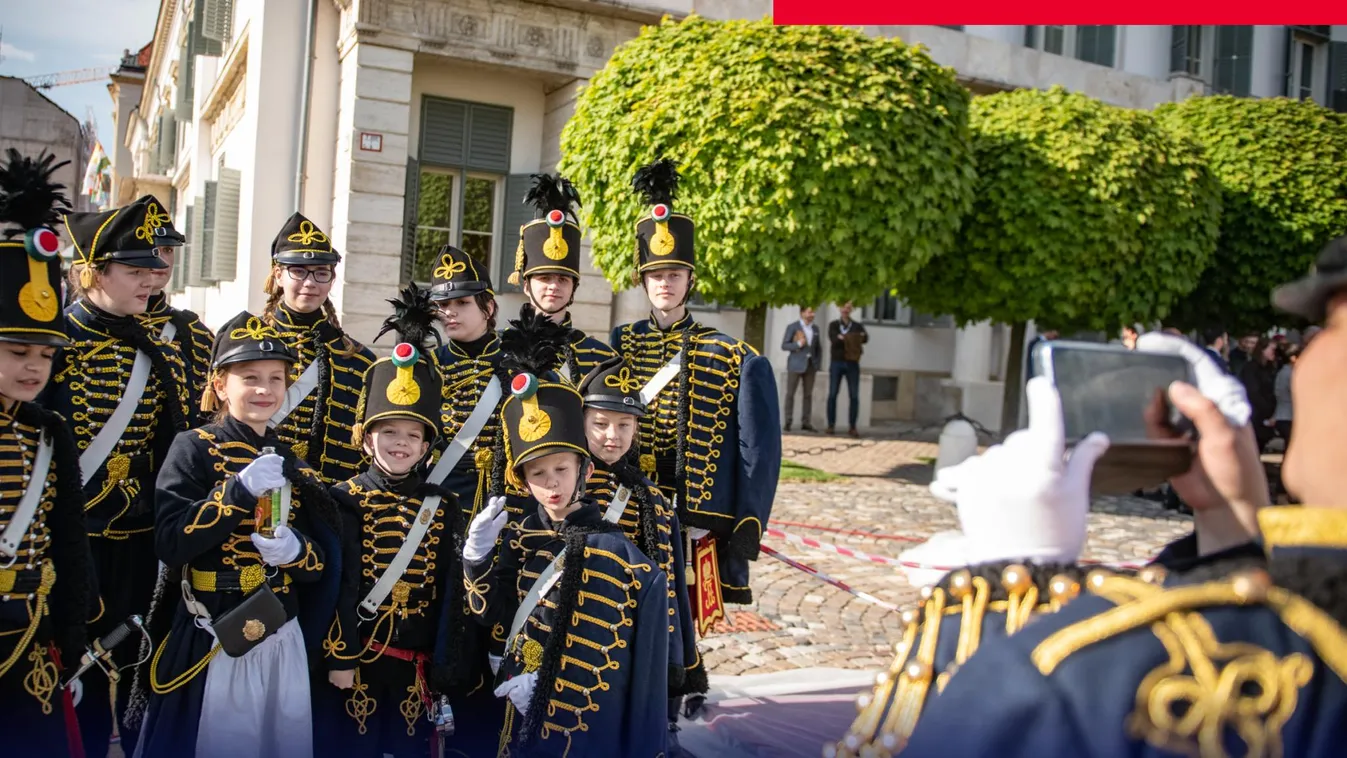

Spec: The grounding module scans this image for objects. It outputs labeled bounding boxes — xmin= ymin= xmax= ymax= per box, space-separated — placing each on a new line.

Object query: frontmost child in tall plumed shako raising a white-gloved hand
xmin=463 ymin=314 xmax=669 ymax=758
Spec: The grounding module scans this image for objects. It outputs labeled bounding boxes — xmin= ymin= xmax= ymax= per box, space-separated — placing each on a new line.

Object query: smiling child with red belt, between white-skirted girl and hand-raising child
xmin=318 ymin=284 xmax=494 ymax=758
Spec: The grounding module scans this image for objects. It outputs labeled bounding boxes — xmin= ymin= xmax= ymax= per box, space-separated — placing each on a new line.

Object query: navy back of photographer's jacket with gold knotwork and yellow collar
xmin=902 ymin=508 xmax=1347 ymax=758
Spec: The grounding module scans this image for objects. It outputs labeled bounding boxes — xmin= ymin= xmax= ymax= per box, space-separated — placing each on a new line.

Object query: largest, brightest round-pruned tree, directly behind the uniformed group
xmin=560 ymin=16 xmax=975 ymax=349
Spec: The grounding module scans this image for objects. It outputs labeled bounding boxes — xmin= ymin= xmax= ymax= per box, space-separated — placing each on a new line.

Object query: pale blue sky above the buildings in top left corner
xmin=0 ymin=0 xmax=159 ymax=149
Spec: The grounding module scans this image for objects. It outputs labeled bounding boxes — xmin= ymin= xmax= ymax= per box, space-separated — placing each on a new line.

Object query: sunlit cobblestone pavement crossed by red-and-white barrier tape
xmin=700 ymin=435 xmax=1191 ymax=675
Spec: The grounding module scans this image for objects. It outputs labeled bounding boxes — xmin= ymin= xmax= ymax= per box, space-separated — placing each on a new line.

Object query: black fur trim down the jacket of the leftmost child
xmin=15 ymin=403 xmax=97 ymax=670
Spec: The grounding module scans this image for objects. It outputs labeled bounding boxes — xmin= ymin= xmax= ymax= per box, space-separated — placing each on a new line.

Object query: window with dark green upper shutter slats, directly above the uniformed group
xmin=403 ymin=97 xmax=511 ymax=289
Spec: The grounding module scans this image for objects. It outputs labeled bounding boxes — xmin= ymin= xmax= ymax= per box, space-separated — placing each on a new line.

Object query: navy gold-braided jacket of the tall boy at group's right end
xmin=610 ymin=309 xmax=781 ymax=603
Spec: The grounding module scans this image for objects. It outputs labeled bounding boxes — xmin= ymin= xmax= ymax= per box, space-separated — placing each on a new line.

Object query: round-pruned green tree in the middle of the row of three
xmin=900 ymin=88 xmax=1220 ymax=431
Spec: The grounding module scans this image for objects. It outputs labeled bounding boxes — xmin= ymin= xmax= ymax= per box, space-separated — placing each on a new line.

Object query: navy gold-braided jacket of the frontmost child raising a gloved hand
xmin=465 ymin=502 xmax=669 ymax=758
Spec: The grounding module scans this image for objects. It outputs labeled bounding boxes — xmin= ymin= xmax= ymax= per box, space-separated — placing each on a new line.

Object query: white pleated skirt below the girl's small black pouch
xmin=197 ymin=619 xmax=314 ymax=758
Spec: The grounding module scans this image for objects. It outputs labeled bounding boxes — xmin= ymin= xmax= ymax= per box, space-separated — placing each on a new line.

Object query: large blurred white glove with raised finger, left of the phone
xmin=931 ymin=377 xmax=1109 ymax=565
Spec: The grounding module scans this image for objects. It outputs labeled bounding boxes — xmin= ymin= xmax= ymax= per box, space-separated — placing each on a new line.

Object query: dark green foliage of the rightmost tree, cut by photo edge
xmin=1156 ymin=96 xmax=1347 ymax=330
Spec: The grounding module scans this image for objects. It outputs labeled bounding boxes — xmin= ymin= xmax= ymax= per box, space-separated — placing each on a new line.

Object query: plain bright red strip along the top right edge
xmin=772 ymin=0 xmax=1347 ymax=26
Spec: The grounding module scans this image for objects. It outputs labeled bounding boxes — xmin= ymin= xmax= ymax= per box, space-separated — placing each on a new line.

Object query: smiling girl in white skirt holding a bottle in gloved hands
xmin=136 ymin=312 xmax=341 ymax=758
